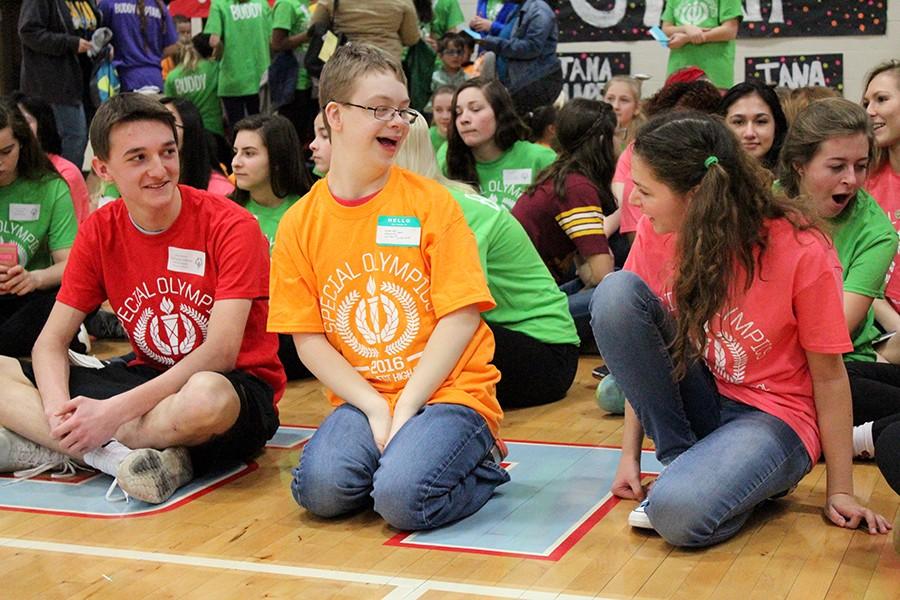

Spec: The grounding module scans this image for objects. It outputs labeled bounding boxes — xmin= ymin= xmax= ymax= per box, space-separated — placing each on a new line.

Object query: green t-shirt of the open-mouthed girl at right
xmin=829 ymin=190 xmax=897 ymax=362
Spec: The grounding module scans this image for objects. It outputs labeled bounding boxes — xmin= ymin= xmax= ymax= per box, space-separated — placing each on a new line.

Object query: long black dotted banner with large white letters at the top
xmin=550 ymin=0 xmax=887 ymax=42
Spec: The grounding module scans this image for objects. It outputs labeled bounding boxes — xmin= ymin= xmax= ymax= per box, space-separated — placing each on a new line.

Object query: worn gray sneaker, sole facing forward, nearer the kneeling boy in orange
xmin=116 ymin=448 xmax=194 ymax=504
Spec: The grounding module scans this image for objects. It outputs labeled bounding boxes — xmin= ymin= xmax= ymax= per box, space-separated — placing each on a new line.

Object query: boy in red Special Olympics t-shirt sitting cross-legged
xmin=0 ymin=94 xmax=285 ymax=503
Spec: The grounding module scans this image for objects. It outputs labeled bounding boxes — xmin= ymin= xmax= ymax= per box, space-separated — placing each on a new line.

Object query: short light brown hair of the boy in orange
xmin=319 ymin=44 xmax=406 ymax=111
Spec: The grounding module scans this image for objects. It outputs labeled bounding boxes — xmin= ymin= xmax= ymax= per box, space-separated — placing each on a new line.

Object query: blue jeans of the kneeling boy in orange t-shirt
xmin=291 ymin=404 xmax=509 ymax=531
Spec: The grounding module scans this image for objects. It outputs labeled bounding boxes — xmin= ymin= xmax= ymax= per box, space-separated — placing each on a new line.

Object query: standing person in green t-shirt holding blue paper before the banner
xmin=662 ymin=0 xmax=743 ymax=90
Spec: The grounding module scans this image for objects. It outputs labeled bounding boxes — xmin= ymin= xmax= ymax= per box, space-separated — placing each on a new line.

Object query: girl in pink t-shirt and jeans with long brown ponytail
xmin=591 ymin=112 xmax=890 ymax=547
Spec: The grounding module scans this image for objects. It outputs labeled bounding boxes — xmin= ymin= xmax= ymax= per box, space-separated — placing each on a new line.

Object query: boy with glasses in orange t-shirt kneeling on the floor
xmin=268 ymin=44 xmax=509 ymax=530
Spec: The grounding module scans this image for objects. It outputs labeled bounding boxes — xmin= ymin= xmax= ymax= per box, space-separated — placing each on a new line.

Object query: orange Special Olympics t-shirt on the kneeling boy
xmin=268 ymin=167 xmax=503 ymax=437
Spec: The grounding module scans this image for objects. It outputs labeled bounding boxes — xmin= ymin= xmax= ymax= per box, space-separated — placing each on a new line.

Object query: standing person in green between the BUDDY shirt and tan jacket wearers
xmin=271 ymin=0 xmax=319 ymax=153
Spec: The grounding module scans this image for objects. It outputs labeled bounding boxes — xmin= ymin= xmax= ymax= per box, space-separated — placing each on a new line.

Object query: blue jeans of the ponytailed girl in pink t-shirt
xmin=591 ymin=271 xmax=812 ymax=547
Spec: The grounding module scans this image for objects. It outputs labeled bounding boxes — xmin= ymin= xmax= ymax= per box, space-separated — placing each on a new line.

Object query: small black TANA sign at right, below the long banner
xmin=744 ymin=54 xmax=844 ymax=94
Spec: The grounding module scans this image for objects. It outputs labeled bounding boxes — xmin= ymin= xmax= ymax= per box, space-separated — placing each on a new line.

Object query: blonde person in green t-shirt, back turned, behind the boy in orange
xmin=395 ymin=112 xmax=579 ymax=409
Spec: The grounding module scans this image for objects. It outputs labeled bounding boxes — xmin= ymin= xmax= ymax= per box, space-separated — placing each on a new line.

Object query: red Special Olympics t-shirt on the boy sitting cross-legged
xmin=57 ymin=185 xmax=285 ymax=402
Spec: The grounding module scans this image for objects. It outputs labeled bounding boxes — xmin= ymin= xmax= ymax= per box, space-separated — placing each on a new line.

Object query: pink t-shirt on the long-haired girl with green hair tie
xmin=625 ymin=219 xmax=853 ymax=462
